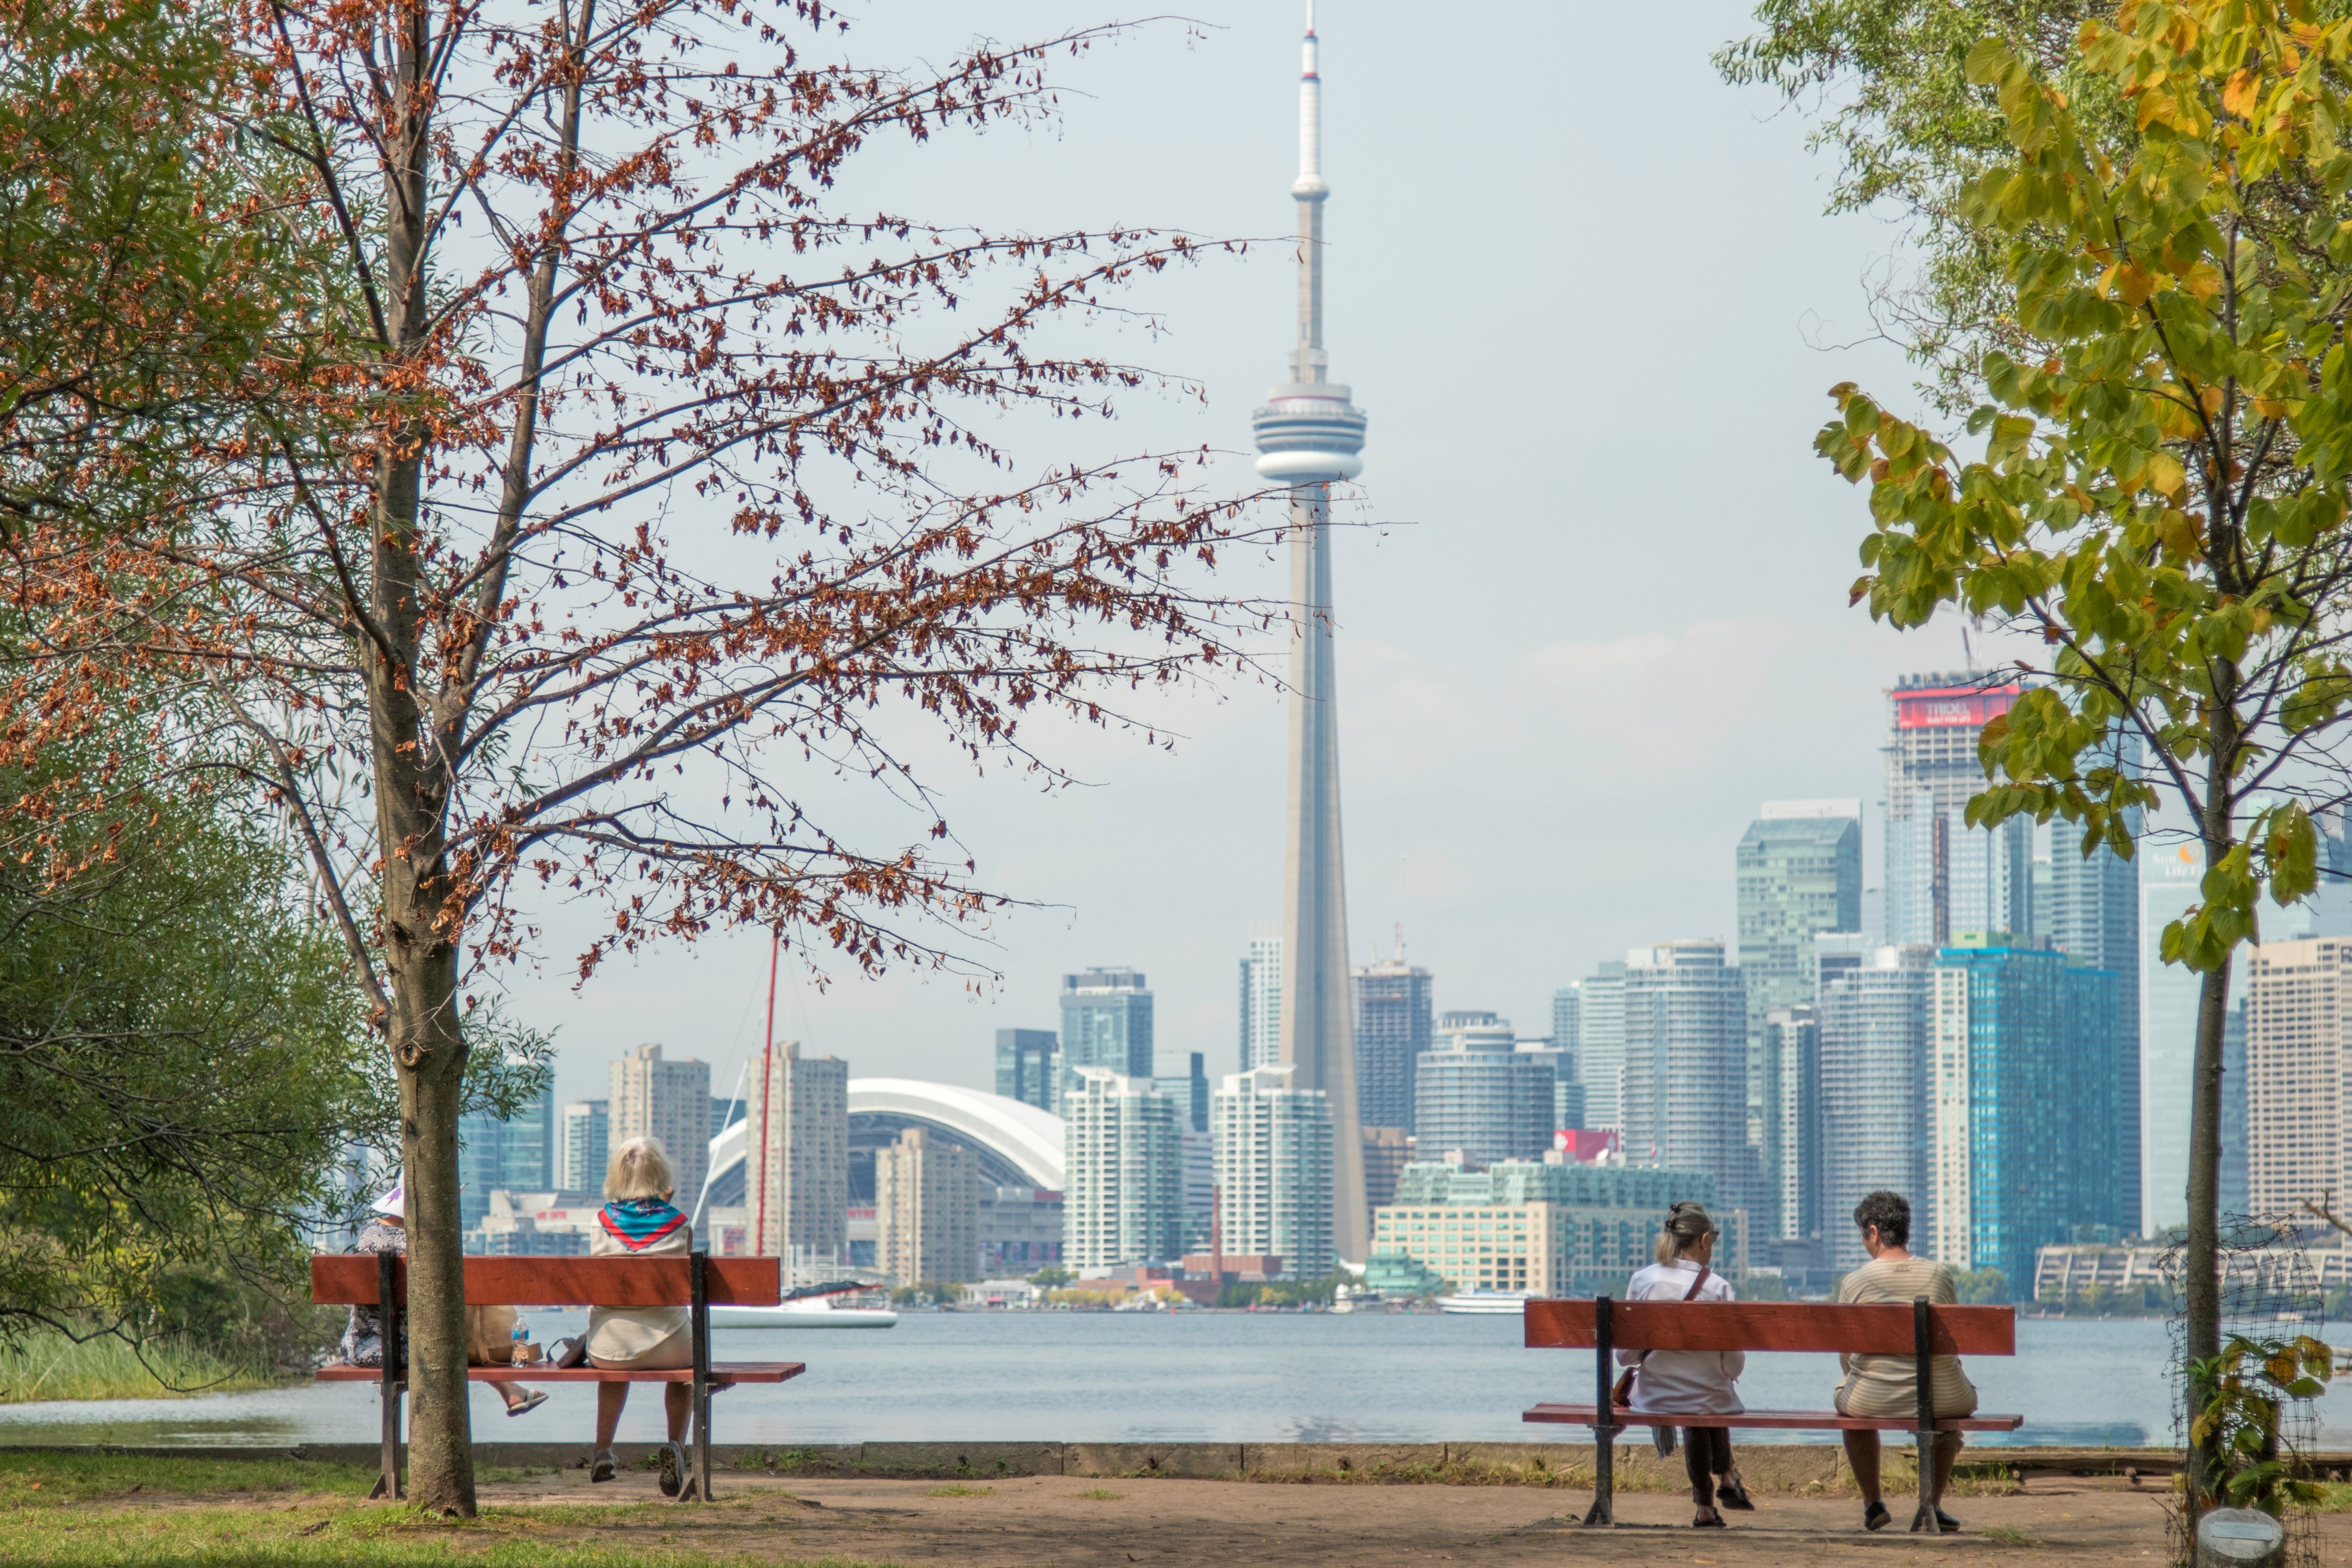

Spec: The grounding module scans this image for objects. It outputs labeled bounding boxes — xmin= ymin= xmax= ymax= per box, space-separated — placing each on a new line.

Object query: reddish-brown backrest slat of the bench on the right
xmin=1526 ymin=1300 xmax=2018 ymax=1356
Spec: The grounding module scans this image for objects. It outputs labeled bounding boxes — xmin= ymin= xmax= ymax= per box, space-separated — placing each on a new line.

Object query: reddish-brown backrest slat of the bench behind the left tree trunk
xmin=310 ymin=1253 xmax=783 ymax=1307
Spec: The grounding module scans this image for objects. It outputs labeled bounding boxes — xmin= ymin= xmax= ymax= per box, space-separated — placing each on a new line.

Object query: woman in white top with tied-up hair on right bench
xmin=1618 ymin=1203 xmax=1755 ymax=1530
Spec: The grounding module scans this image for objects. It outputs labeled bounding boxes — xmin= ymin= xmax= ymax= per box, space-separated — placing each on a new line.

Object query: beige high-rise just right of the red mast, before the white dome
xmin=743 ymin=1039 xmax=849 ymax=1267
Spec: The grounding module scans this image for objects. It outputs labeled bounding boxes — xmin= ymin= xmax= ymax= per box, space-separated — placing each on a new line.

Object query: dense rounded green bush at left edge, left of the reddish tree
xmin=0 ymin=733 xmax=372 ymax=1338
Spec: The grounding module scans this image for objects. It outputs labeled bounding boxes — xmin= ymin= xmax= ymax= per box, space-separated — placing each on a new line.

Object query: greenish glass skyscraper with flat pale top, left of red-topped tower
xmin=1733 ymin=799 xmax=1863 ymax=1032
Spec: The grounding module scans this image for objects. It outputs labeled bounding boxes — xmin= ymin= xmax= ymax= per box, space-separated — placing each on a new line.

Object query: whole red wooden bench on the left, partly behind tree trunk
xmin=310 ymin=1253 xmax=807 ymax=1502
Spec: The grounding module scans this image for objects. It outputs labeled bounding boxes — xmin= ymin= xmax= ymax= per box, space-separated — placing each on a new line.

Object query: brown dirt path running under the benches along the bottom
xmin=485 ymin=1472 xmax=2352 ymax=1568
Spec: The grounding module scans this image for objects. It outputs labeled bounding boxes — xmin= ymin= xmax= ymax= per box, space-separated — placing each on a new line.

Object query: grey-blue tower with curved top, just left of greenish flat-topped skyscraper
xmin=1618 ymin=940 xmax=1757 ymax=1213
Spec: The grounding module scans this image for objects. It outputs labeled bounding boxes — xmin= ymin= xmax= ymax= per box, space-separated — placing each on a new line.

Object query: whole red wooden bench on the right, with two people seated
xmin=1522 ymin=1295 xmax=2025 ymax=1535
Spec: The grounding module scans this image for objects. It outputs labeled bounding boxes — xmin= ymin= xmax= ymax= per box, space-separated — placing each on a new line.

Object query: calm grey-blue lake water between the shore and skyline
xmin=0 ymin=1312 xmax=2239 ymax=1446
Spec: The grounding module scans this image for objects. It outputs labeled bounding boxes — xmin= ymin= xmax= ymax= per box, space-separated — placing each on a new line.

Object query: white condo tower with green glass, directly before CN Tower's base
xmin=1209 ymin=1065 xmax=1362 ymax=1279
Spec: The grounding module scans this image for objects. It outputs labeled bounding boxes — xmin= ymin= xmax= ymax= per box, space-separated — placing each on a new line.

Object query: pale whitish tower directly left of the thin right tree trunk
xmin=2138 ymin=839 xmax=2201 ymax=1234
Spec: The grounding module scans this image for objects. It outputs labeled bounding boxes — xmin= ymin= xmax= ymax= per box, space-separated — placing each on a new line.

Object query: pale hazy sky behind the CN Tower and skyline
xmin=515 ymin=0 xmax=1959 ymax=1114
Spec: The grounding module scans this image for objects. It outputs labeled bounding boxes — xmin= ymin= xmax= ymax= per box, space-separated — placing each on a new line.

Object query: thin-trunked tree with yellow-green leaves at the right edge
xmin=1816 ymin=0 xmax=2352 ymax=1497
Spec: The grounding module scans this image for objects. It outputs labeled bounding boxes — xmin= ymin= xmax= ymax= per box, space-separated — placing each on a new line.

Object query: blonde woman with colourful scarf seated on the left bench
xmin=586 ymin=1138 xmax=694 ymax=1497
